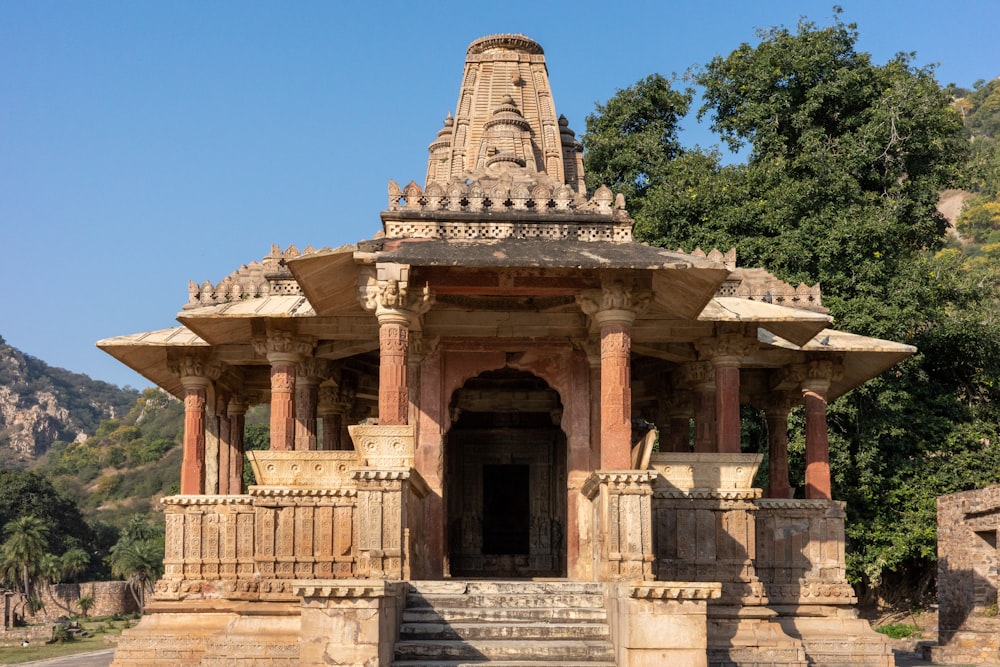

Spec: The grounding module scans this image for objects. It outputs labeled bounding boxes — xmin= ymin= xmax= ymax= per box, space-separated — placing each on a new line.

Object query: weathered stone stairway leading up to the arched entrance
xmin=392 ymin=580 xmax=615 ymax=667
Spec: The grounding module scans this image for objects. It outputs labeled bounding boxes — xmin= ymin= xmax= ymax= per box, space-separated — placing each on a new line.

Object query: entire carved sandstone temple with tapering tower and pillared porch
xmin=98 ymin=35 xmax=914 ymax=667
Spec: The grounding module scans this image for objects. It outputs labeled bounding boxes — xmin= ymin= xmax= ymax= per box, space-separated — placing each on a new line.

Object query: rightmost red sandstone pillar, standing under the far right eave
xmin=802 ymin=359 xmax=837 ymax=500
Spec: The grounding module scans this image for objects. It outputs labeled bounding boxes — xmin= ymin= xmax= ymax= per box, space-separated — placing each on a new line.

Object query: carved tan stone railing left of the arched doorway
xmin=155 ymin=436 xmax=427 ymax=601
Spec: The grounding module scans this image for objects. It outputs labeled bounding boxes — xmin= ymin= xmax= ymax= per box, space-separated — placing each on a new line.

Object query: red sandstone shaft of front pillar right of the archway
xmin=595 ymin=310 xmax=635 ymax=470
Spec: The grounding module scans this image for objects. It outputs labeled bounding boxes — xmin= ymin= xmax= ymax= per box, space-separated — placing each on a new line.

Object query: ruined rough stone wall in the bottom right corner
xmin=932 ymin=486 xmax=1000 ymax=664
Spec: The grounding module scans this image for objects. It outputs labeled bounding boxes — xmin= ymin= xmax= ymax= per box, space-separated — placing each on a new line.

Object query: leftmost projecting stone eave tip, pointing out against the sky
xmin=96 ymin=327 xmax=209 ymax=399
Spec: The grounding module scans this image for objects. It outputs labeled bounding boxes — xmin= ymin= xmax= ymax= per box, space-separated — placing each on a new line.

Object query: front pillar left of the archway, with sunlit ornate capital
xmin=362 ymin=264 xmax=433 ymax=426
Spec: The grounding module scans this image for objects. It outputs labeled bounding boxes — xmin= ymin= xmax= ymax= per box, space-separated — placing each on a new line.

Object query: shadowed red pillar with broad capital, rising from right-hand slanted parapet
xmin=697 ymin=332 xmax=757 ymax=454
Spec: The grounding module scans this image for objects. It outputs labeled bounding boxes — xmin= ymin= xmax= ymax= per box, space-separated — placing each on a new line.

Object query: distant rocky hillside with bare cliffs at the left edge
xmin=0 ymin=336 xmax=139 ymax=468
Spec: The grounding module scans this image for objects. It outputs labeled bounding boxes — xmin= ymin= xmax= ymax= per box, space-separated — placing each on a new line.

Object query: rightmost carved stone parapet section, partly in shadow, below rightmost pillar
xmin=756 ymin=498 xmax=857 ymax=605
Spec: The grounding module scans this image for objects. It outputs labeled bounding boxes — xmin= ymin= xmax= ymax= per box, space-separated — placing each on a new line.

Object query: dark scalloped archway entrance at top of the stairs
xmin=445 ymin=368 xmax=566 ymax=577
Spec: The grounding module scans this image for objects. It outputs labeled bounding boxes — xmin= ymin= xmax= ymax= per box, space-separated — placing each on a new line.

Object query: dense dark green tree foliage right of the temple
xmin=583 ymin=10 xmax=1000 ymax=594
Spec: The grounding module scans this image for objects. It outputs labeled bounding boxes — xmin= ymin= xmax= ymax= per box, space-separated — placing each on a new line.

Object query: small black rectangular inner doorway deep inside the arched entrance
xmin=483 ymin=465 xmax=531 ymax=556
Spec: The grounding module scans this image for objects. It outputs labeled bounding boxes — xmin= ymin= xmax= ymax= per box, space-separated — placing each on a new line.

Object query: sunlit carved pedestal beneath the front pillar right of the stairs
xmin=581 ymin=470 xmax=656 ymax=581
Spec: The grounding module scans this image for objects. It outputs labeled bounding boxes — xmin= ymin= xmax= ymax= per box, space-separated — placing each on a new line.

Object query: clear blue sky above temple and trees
xmin=0 ymin=0 xmax=1000 ymax=388
